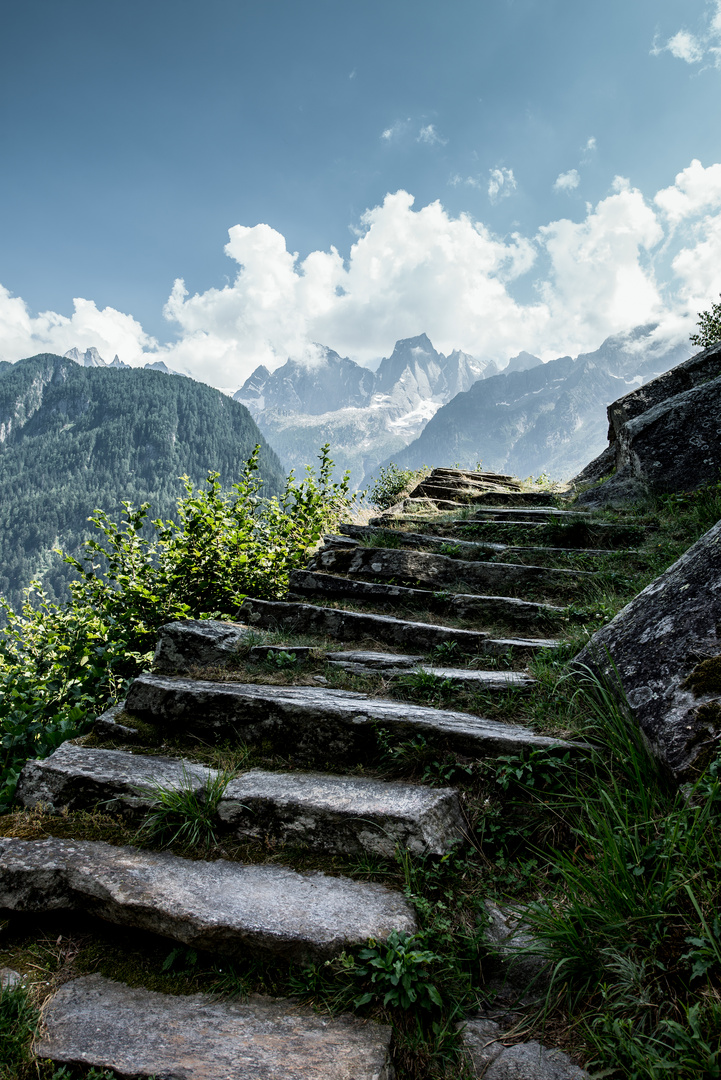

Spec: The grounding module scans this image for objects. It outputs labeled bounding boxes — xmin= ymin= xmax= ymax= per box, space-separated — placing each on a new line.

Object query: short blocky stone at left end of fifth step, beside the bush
xmin=153 ymin=619 xmax=250 ymax=672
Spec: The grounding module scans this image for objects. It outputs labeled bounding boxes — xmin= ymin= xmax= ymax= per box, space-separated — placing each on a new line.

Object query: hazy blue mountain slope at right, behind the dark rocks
xmin=381 ymin=325 xmax=692 ymax=480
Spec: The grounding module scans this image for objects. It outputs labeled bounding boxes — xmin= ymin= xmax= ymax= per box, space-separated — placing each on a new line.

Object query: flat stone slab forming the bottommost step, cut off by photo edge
xmin=33 ymin=975 xmax=393 ymax=1080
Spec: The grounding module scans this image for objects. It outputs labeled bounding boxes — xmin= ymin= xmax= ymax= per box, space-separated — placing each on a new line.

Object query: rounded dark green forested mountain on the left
xmin=0 ymin=353 xmax=284 ymax=607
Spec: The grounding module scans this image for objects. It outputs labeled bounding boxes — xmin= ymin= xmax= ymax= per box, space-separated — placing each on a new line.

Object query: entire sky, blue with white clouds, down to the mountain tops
xmin=0 ymin=0 xmax=721 ymax=386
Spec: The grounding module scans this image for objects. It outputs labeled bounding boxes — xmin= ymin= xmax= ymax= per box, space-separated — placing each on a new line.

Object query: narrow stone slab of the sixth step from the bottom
xmin=242 ymin=599 xmax=489 ymax=654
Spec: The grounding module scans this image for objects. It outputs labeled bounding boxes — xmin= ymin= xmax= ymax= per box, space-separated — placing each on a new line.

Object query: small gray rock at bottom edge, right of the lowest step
xmin=461 ymin=1018 xmax=588 ymax=1080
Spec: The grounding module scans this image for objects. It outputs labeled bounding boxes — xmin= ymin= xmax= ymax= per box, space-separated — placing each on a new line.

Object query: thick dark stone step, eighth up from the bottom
xmin=306 ymin=545 xmax=593 ymax=596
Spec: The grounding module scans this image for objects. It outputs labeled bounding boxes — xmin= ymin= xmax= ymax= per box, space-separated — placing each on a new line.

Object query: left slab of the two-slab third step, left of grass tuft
xmin=16 ymin=743 xmax=216 ymax=818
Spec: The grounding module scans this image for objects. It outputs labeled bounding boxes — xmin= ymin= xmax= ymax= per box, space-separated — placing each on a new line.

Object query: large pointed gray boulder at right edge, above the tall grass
xmin=574 ymin=523 xmax=721 ymax=779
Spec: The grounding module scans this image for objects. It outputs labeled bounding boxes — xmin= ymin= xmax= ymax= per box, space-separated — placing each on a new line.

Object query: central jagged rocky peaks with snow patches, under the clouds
xmin=234 ymin=334 xmax=496 ymax=484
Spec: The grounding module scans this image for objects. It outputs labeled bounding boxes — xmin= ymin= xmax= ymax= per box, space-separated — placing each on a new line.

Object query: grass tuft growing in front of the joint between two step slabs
xmin=136 ymin=766 xmax=233 ymax=848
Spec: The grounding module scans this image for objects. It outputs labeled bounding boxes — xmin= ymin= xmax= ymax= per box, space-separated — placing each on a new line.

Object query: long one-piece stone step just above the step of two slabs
xmin=126 ymin=675 xmax=570 ymax=768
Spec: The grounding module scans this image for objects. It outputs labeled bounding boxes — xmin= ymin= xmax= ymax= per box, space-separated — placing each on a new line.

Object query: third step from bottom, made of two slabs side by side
xmin=17 ymin=743 xmax=463 ymax=858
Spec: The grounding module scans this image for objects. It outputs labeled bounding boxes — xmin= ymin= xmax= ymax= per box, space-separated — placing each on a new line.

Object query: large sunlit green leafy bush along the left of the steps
xmin=0 ymin=445 xmax=355 ymax=811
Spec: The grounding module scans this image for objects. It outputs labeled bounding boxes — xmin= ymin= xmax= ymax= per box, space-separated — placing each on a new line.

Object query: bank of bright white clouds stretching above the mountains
xmin=0 ymin=161 xmax=721 ymax=388
